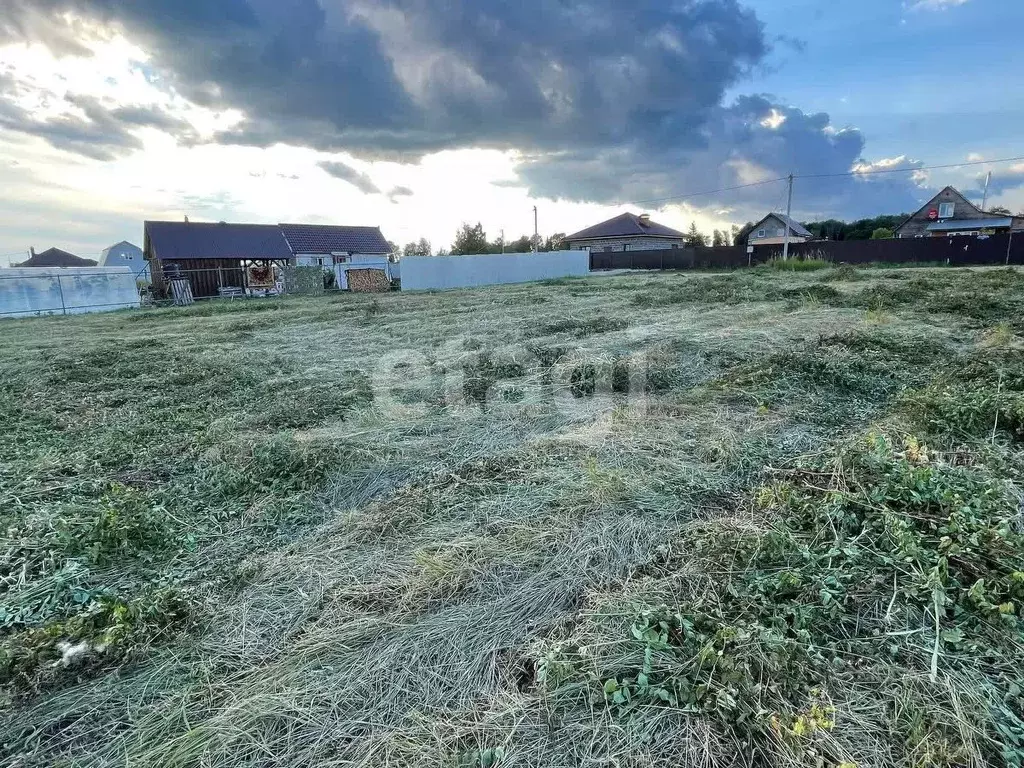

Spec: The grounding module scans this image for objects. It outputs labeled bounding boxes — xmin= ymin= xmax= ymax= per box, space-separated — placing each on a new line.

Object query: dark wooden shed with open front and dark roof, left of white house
xmin=142 ymin=221 xmax=292 ymax=298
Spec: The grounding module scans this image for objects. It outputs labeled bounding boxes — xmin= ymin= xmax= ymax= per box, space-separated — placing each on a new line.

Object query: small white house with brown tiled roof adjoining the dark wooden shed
xmin=281 ymin=224 xmax=397 ymax=292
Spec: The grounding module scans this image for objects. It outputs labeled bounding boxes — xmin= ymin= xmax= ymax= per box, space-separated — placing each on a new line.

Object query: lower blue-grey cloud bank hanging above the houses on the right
xmin=519 ymin=96 xmax=922 ymax=218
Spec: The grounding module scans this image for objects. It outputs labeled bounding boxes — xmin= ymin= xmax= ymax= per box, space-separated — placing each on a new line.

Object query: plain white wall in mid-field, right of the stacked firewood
xmin=401 ymin=251 xmax=590 ymax=291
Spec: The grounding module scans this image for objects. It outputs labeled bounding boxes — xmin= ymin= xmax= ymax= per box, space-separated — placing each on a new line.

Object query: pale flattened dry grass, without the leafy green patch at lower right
xmin=0 ymin=269 xmax=1024 ymax=768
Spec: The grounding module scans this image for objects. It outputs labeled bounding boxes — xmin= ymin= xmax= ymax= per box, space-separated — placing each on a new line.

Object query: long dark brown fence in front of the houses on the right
xmin=590 ymin=232 xmax=1024 ymax=269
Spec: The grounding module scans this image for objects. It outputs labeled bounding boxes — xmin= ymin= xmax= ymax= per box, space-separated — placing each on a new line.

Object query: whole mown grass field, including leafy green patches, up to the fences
xmin=0 ymin=267 xmax=1024 ymax=768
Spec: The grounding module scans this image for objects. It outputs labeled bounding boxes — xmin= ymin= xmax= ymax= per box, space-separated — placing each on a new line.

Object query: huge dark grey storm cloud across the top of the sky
xmin=0 ymin=0 xmax=766 ymax=153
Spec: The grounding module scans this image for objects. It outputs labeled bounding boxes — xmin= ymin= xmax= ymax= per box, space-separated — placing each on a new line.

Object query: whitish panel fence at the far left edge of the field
xmin=0 ymin=266 xmax=139 ymax=317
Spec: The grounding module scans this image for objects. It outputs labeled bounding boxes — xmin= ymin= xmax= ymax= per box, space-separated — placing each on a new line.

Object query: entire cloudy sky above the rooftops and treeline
xmin=0 ymin=0 xmax=1024 ymax=265
